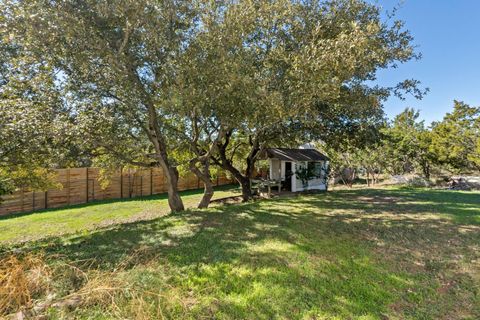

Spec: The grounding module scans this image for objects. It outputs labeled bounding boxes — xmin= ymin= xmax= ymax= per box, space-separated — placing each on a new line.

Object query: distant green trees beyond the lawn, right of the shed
xmin=326 ymin=101 xmax=480 ymax=186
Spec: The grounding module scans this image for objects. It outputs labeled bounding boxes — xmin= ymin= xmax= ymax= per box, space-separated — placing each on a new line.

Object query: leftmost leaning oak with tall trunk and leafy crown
xmin=2 ymin=0 xmax=201 ymax=211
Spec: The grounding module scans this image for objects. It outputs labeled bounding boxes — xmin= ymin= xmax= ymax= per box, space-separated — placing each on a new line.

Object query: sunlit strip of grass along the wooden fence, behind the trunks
xmin=0 ymin=185 xmax=239 ymax=243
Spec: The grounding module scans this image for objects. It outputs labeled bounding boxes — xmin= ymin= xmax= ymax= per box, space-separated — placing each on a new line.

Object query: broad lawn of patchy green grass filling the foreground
xmin=0 ymin=188 xmax=480 ymax=319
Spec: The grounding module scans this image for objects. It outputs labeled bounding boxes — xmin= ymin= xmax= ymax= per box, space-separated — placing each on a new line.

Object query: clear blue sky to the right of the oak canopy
xmin=372 ymin=0 xmax=480 ymax=124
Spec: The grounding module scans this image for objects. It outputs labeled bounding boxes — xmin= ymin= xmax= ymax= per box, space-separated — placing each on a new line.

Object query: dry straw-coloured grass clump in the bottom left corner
xmin=0 ymin=254 xmax=120 ymax=316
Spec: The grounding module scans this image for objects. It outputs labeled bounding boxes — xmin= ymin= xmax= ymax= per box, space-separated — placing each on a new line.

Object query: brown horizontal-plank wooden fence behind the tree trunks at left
xmin=0 ymin=168 xmax=232 ymax=215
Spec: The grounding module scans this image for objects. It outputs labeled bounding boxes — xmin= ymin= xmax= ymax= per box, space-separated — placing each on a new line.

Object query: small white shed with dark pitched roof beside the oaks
xmin=262 ymin=148 xmax=329 ymax=192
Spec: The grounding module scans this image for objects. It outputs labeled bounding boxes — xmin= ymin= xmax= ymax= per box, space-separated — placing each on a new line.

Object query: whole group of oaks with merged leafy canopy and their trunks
xmin=0 ymin=0 xmax=428 ymax=211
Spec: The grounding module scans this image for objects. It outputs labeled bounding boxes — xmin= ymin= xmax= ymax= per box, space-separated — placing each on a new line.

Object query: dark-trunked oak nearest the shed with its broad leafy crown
xmin=174 ymin=0 xmax=421 ymax=200
